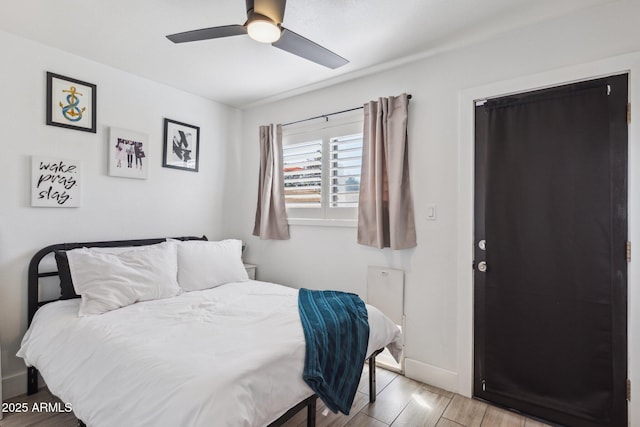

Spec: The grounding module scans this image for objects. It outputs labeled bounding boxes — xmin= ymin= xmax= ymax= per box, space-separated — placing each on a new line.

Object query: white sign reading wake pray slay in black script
xmin=31 ymin=156 xmax=80 ymax=208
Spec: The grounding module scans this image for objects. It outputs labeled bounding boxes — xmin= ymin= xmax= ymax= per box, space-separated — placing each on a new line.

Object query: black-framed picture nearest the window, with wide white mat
xmin=162 ymin=119 xmax=200 ymax=172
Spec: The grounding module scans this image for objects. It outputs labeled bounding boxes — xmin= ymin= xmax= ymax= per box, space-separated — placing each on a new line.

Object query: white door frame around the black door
xmin=457 ymin=52 xmax=640 ymax=423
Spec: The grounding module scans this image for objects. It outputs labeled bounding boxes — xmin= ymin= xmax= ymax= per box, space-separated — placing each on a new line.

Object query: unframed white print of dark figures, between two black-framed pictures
xmin=109 ymin=127 xmax=149 ymax=179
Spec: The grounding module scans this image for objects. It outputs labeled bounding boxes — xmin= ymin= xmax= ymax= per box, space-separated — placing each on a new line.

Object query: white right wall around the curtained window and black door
xmin=227 ymin=0 xmax=640 ymax=425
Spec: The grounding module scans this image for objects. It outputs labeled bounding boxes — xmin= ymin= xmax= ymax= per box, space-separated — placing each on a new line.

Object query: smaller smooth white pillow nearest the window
xmin=178 ymin=239 xmax=249 ymax=291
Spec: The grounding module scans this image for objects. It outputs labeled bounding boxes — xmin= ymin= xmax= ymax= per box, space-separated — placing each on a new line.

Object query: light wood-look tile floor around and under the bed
xmin=0 ymin=366 xmax=546 ymax=427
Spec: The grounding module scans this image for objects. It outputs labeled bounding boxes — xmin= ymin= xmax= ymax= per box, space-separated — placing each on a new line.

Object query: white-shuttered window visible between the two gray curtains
xmin=283 ymin=117 xmax=362 ymax=225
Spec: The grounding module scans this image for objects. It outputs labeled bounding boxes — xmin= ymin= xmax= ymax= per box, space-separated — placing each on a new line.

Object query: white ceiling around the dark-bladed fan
xmin=0 ymin=0 xmax=613 ymax=108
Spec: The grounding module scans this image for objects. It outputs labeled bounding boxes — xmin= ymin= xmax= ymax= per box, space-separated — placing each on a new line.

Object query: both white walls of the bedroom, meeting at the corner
xmin=0 ymin=0 xmax=640 ymax=425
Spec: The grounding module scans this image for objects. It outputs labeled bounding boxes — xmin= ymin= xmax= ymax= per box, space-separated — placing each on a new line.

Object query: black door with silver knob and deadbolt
xmin=474 ymin=74 xmax=627 ymax=426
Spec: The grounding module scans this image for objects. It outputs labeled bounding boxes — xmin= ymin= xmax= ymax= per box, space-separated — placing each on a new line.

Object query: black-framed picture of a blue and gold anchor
xmin=47 ymin=72 xmax=96 ymax=133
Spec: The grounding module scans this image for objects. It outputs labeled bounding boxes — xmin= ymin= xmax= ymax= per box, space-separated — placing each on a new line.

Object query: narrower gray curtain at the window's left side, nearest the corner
xmin=253 ymin=125 xmax=289 ymax=240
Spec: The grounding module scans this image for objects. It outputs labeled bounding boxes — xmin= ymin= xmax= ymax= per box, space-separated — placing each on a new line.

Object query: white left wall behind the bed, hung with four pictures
xmin=0 ymin=32 xmax=241 ymax=397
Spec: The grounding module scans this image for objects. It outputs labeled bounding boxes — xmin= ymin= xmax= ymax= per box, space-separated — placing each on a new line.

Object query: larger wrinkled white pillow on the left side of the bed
xmin=67 ymin=242 xmax=180 ymax=316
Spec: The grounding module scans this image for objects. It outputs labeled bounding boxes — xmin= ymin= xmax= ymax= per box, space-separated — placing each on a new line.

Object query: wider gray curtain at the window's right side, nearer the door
xmin=358 ymin=94 xmax=417 ymax=249
